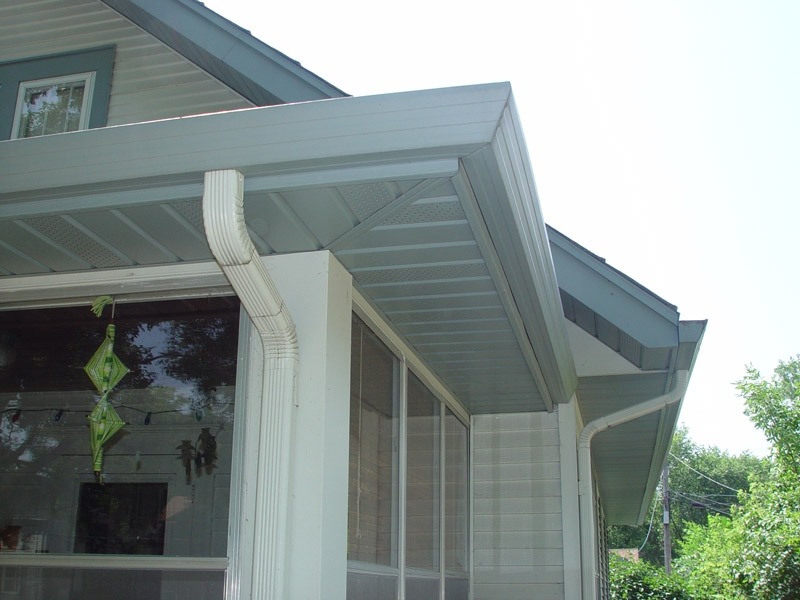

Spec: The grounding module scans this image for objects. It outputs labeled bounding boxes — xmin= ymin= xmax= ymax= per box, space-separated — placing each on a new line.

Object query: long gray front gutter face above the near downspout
xmin=0 ymin=84 xmax=510 ymax=196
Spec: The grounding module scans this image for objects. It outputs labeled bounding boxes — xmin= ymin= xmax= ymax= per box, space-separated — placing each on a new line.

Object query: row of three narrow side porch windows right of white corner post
xmin=347 ymin=316 xmax=469 ymax=600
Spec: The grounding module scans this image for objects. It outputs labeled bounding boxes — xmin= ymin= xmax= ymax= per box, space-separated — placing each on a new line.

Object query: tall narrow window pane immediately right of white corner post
xmin=347 ymin=317 xmax=398 ymax=566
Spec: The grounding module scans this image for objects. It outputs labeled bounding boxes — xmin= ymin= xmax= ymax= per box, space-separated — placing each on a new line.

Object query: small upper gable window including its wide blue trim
xmin=0 ymin=47 xmax=114 ymax=139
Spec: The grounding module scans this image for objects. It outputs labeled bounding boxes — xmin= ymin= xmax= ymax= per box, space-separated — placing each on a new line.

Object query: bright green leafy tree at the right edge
xmin=678 ymin=358 xmax=800 ymax=600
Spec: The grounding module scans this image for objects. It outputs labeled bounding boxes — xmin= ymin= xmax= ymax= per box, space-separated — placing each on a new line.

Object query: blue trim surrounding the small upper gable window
xmin=0 ymin=46 xmax=116 ymax=140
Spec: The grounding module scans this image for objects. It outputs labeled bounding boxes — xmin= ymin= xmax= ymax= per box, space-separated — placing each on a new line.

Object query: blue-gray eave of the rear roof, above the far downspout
xmin=564 ymin=229 xmax=706 ymax=525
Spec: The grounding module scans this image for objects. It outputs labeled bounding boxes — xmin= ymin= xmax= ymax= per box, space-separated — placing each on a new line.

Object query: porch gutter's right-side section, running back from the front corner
xmin=463 ymin=99 xmax=578 ymax=403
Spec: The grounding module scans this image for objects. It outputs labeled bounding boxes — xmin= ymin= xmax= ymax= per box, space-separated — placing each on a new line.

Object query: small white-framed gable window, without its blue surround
xmin=15 ymin=73 xmax=94 ymax=138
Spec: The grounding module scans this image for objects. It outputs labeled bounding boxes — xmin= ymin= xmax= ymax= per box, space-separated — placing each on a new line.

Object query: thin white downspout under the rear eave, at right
xmin=578 ymin=371 xmax=689 ymax=600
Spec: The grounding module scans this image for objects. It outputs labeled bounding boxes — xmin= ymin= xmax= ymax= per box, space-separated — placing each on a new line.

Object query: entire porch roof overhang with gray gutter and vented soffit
xmin=0 ymin=84 xmax=577 ymax=413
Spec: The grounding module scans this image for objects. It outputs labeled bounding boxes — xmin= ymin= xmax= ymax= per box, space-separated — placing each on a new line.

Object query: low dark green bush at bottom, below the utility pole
xmin=609 ymin=555 xmax=692 ymax=600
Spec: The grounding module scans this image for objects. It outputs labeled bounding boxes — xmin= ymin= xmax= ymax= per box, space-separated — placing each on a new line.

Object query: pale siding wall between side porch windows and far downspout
xmin=472 ymin=413 xmax=564 ymax=600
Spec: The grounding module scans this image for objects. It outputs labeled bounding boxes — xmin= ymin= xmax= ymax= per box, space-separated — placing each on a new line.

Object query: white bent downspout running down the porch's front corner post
xmin=203 ymin=170 xmax=299 ymax=600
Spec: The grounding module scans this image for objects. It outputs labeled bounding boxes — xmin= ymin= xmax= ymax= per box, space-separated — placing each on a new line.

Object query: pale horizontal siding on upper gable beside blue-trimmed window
xmin=0 ymin=0 xmax=250 ymax=125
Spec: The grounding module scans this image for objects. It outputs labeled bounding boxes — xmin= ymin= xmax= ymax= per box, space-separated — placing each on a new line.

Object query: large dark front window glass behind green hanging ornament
xmin=0 ymin=298 xmax=239 ymax=564
